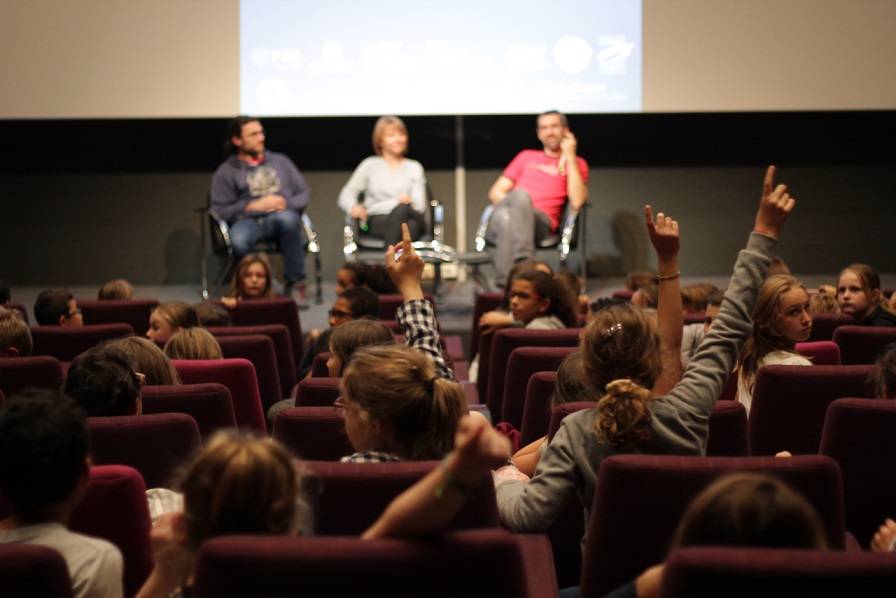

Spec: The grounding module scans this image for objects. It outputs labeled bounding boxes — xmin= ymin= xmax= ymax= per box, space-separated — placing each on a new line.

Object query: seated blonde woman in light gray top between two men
xmin=339 ymin=116 xmax=426 ymax=245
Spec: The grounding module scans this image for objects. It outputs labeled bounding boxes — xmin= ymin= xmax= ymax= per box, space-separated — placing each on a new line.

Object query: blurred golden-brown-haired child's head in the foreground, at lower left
xmin=179 ymin=432 xmax=312 ymax=551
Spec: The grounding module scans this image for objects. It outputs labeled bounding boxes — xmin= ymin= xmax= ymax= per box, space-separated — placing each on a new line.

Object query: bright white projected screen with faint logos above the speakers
xmin=240 ymin=0 xmax=642 ymax=116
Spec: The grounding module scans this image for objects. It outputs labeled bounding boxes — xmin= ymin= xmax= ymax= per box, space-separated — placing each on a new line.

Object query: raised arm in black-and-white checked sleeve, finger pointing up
xmin=386 ymin=222 xmax=454 ymax=381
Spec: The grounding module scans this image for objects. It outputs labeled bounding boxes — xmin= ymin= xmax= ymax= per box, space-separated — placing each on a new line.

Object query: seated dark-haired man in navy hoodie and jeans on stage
xmin=211 ymin=116 xmax=311 ymax=304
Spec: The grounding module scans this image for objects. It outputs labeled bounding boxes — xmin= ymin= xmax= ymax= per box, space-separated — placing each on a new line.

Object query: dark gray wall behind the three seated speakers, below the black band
xmin=0 ymin=165 xmax=896 ymax=286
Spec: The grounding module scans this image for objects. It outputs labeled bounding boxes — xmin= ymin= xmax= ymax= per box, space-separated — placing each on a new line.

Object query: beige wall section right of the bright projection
xmin=643 ymin=0 xmax=896 ymax=112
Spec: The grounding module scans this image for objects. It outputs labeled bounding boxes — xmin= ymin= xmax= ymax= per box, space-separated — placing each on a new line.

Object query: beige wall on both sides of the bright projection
xmin=0 ymin=0 xmax=896 ymax=118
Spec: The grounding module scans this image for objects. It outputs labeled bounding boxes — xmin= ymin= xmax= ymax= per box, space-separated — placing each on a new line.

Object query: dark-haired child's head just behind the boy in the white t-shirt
xmin=65 ymin=345 xmax=142 ymax=417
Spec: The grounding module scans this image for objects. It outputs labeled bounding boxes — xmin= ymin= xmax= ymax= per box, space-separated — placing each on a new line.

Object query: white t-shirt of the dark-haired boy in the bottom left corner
xmin=0 ymin=523 xmax=123 ymax=598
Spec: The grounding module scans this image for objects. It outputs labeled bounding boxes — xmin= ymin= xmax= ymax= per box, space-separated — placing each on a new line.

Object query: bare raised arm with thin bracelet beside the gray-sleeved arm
xmin=644 ymin=205 xmax=684 ymax=395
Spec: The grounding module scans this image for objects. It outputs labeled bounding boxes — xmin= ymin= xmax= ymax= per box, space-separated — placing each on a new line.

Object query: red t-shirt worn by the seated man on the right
xmin=504 ymin=150 xmax=588 ymax=230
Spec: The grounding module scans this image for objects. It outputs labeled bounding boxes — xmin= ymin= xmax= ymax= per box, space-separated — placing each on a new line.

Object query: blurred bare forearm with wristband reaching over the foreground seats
xmin=361 ymin=415 xmax=510 ymax=539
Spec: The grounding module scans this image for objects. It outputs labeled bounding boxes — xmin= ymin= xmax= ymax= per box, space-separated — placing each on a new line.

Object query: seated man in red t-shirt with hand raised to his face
xmin=486 ymin=110 xmax=588 ymax=286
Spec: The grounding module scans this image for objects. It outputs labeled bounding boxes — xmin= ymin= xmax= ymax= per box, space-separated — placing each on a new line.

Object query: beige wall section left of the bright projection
xmin=0 ymin=0 xmax=239 ymax=118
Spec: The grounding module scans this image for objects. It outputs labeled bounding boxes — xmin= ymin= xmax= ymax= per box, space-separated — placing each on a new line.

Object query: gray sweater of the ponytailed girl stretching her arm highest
xmin=496 ymin=233 xmax=775 ymax=532
